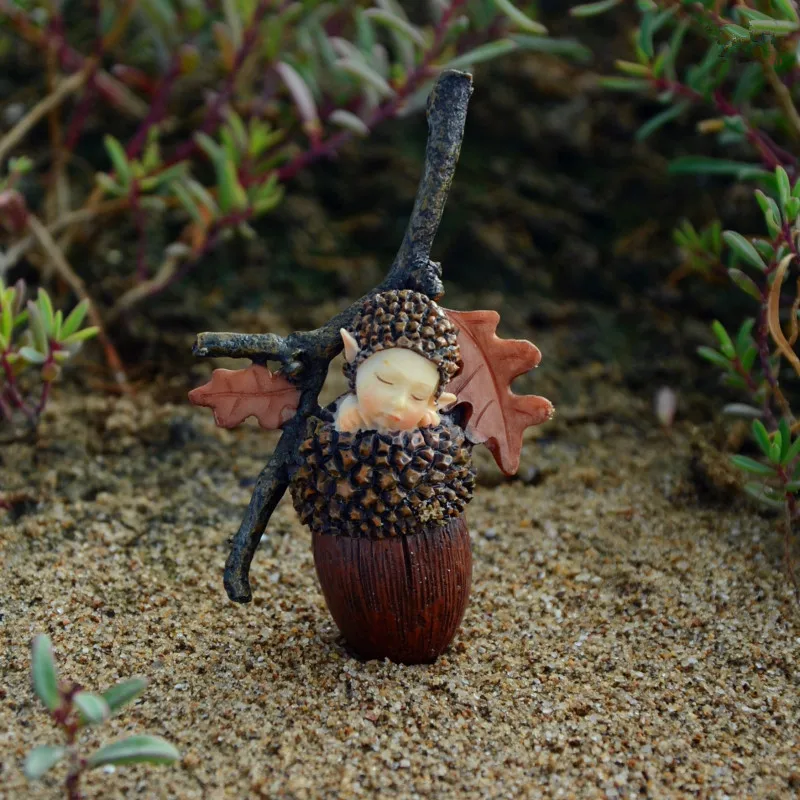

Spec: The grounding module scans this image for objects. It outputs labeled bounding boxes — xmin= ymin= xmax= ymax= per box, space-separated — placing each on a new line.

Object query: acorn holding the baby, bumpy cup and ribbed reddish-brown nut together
xmin=291 ymin=418 xmax=475 ymax=664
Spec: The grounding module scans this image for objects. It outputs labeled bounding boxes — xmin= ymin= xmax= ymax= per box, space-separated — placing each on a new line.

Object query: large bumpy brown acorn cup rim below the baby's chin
xmin=291 ymin=412 xmax=475 ymax=539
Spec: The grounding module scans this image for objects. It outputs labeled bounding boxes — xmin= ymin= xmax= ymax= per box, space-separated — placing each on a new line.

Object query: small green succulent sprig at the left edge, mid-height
xmin=0 ymin=280 xmax=98 ymax=427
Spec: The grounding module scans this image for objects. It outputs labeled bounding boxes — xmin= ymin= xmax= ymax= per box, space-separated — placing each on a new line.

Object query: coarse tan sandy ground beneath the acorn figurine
xmin=0 ymin=372 xmax=800 ymax=800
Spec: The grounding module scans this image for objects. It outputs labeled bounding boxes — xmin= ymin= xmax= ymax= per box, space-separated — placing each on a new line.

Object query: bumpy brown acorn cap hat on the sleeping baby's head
xmin=344 ymin=289 xmax=461 ymax=398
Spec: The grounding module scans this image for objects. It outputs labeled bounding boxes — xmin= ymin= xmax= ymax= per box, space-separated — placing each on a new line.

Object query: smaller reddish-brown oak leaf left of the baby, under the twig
xmin=189 ymin=364 xmax=300 ymax=430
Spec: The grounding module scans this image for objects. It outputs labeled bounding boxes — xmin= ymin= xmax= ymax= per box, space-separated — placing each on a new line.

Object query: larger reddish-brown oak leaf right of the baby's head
xmin=445 ymin=308 xmax=554 ymax=475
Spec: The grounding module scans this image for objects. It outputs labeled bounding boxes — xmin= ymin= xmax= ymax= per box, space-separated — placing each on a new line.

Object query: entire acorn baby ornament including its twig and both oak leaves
xmin=190 ymin=70 xmax=553 ymax=664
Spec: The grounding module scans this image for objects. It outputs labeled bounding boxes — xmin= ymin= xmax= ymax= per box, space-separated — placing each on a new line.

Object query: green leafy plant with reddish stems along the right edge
xmin=572 ymin=0 xmax=800 ymax=600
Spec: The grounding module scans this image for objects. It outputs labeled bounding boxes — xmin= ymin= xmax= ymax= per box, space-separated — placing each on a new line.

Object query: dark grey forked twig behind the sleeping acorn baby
xmin=193 ymin=70 xmax=472 ymax=603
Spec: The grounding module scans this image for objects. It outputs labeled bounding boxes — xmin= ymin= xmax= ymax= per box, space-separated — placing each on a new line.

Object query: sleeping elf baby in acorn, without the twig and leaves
xmin=291 ymin=289 xmax=475 ymax=663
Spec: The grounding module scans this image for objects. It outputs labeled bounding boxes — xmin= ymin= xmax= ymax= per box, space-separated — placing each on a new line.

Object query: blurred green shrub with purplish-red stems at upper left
xmin=0 ymin=0 xmax=586 ymax=384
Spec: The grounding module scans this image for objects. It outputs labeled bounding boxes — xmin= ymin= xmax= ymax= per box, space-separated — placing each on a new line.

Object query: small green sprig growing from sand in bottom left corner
xmin=24 ymin=634 xmax=180 ymax=800
